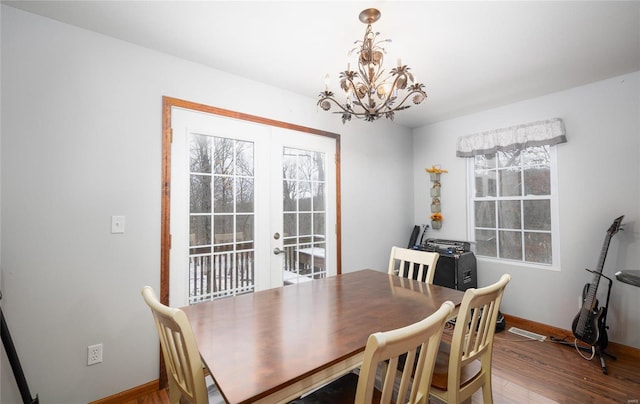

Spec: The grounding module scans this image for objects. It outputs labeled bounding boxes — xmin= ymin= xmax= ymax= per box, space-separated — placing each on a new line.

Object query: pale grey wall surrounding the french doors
xmin=0 ymin=5 xmax=413 ymax=403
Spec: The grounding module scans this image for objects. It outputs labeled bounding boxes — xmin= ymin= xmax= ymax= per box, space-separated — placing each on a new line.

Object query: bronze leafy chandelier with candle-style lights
xmin=317 ymin=8 xmax=427 ymax=124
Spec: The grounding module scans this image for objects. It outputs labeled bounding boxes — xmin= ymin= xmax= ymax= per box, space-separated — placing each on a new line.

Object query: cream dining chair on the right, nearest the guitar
xmin=431 ymin=274 xmax=511 ymax=404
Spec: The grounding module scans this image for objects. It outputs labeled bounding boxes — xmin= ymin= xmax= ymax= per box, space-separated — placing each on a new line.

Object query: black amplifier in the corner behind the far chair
xmin=413 ymin=239 xmax=478 ymax=290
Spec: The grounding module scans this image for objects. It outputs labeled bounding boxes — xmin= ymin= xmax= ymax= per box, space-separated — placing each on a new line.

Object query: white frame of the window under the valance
xmin=466 ymin=145 xmax=561 ymax=272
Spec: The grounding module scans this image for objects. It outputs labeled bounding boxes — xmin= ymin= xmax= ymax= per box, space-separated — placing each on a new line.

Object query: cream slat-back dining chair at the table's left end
xmin=142 ymin=286 xmax=209 ymax=404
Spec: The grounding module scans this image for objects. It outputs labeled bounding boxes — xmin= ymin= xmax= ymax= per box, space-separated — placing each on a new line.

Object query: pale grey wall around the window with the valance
xmin=413 ymin=72 xmax=640 ymax=348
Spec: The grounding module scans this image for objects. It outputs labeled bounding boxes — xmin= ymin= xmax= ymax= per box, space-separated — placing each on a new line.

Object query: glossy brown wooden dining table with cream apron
xmin=182 ymin=269 xmax=464 ymax=403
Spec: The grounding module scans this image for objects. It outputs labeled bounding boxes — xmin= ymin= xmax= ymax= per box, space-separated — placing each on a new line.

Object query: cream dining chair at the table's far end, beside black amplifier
xmin=389 ymin=246 xmax=440 ymax=283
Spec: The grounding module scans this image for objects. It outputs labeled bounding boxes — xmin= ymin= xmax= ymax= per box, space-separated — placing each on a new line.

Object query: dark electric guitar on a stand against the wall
xmin=571 ymin=215 xmax=624 ymax=349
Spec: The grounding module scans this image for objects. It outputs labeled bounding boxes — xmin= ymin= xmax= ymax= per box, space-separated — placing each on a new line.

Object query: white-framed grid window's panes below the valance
xmin=467 ymin=145 xmax=558 ymax=267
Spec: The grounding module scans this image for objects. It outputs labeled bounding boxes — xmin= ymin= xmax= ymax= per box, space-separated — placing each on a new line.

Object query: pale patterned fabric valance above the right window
xmin=456 ymin=118 xmax=567 ymax=157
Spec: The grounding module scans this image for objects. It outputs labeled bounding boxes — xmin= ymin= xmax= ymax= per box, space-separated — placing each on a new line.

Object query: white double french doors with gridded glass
xmin=169 ymin=107 xmax=337 ymax=307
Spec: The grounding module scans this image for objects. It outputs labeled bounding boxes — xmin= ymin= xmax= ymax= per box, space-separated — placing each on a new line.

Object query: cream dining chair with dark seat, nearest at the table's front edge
xmin=292 ymin=301 xmax=454 ymax=404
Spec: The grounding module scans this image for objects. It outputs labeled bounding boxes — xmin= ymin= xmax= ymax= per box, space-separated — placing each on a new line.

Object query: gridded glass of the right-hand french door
xmin=282 ymin=147 xmax=326 ymax=284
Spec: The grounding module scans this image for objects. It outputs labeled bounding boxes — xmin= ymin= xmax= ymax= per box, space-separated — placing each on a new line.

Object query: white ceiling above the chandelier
xmin=2 ymin=0 xmax=640 ymax=127
